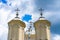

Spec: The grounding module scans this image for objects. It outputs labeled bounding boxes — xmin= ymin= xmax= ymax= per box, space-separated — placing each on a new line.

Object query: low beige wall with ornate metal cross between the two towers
xmin=25 ymin=22 xmax=35 ymax=40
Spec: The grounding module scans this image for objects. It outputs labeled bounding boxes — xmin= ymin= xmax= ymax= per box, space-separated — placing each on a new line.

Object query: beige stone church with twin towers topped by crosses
xmin=8 ymin=9 xmax=51 ymax=40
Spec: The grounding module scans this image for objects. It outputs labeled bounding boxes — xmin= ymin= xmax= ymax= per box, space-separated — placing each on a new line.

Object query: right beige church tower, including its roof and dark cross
xmin=34 ymin=8 xmax=51 ymax=40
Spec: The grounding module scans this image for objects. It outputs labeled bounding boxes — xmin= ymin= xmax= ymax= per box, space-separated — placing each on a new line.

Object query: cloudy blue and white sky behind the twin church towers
xmin=0 ymin=0 xmax=60 ymax=40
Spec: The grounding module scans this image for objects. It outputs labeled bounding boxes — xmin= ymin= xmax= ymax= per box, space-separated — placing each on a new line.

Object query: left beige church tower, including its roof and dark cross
xmin=8 ymin=8 xmax=25 ymax=40
